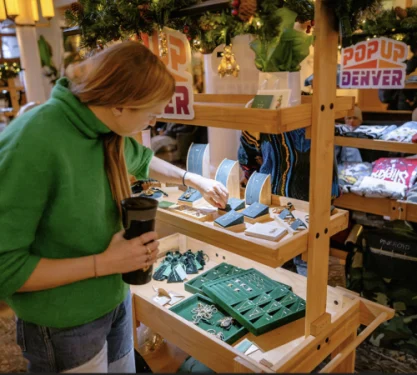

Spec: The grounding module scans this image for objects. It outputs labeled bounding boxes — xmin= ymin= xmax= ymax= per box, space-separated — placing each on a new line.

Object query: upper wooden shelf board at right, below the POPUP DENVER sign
xmin=334 ymin=136 xmax=417 ymax=154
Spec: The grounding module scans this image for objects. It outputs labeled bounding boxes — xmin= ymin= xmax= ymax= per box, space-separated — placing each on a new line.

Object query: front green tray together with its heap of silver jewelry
xmin=170 ymin=294 xmax=247 ymax=344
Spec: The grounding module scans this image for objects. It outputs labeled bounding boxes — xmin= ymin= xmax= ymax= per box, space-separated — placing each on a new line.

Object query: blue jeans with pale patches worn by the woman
xmin=16 ymin=293 xmax=136 ymax=373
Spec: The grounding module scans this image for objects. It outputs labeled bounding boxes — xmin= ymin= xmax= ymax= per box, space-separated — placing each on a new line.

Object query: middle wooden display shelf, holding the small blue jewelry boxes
xmin=157 ymin=191 xmax=348 ymax=267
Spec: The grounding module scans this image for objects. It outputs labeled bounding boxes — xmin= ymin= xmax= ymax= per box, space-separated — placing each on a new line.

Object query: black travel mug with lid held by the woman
xmin=121 ymin=197 xmax=158 ymax=285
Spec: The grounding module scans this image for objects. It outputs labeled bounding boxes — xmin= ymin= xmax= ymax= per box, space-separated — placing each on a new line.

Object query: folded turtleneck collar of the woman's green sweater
xmin=51 ymin=77 xmax=111 ymax=139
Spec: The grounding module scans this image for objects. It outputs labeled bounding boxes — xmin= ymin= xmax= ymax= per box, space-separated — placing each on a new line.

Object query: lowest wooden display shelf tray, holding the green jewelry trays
xmin=131 ymin=234 xmax=394 ymax=373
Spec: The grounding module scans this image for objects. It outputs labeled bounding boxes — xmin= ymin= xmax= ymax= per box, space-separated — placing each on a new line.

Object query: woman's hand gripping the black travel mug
xmin=96 ymin=230 xmax=159 ymax=276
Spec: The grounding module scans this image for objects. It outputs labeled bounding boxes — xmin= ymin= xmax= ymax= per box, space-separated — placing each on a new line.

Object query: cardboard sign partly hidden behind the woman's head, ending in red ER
xmin=141 ymin=27 xmax=194 ymax=120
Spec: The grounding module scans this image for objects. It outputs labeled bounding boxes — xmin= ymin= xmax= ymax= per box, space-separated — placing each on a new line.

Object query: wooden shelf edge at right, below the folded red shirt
xmin=334 ymin=194 xmax=417 ymax=223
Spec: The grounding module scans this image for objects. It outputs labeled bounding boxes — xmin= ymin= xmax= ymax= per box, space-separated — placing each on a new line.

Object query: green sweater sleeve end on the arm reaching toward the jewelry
xmin=125 ymin=138 xmax=153 ymax=180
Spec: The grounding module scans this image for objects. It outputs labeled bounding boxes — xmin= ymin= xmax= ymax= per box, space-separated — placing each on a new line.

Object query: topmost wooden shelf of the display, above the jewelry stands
xmin=160 ymin=94 xmax=354 ymax=134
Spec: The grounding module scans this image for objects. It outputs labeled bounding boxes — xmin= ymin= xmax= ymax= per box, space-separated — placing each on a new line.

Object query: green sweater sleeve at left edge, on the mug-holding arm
xmin=0 ymin=130 xmax=53 ymax=300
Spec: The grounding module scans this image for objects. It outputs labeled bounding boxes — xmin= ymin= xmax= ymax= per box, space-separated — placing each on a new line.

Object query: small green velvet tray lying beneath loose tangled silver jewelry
xmin=170 ymin=293 xmax=248 ymax=344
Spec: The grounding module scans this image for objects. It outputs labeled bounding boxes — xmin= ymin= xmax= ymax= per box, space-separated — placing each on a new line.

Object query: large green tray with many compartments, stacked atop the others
xmin=202 ymin=268 xmax=305 ymax=336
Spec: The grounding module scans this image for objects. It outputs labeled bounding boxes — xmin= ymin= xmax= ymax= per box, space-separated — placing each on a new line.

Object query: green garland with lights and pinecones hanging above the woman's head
xmin=66 ymin=0 xmax=314 ymax=53
